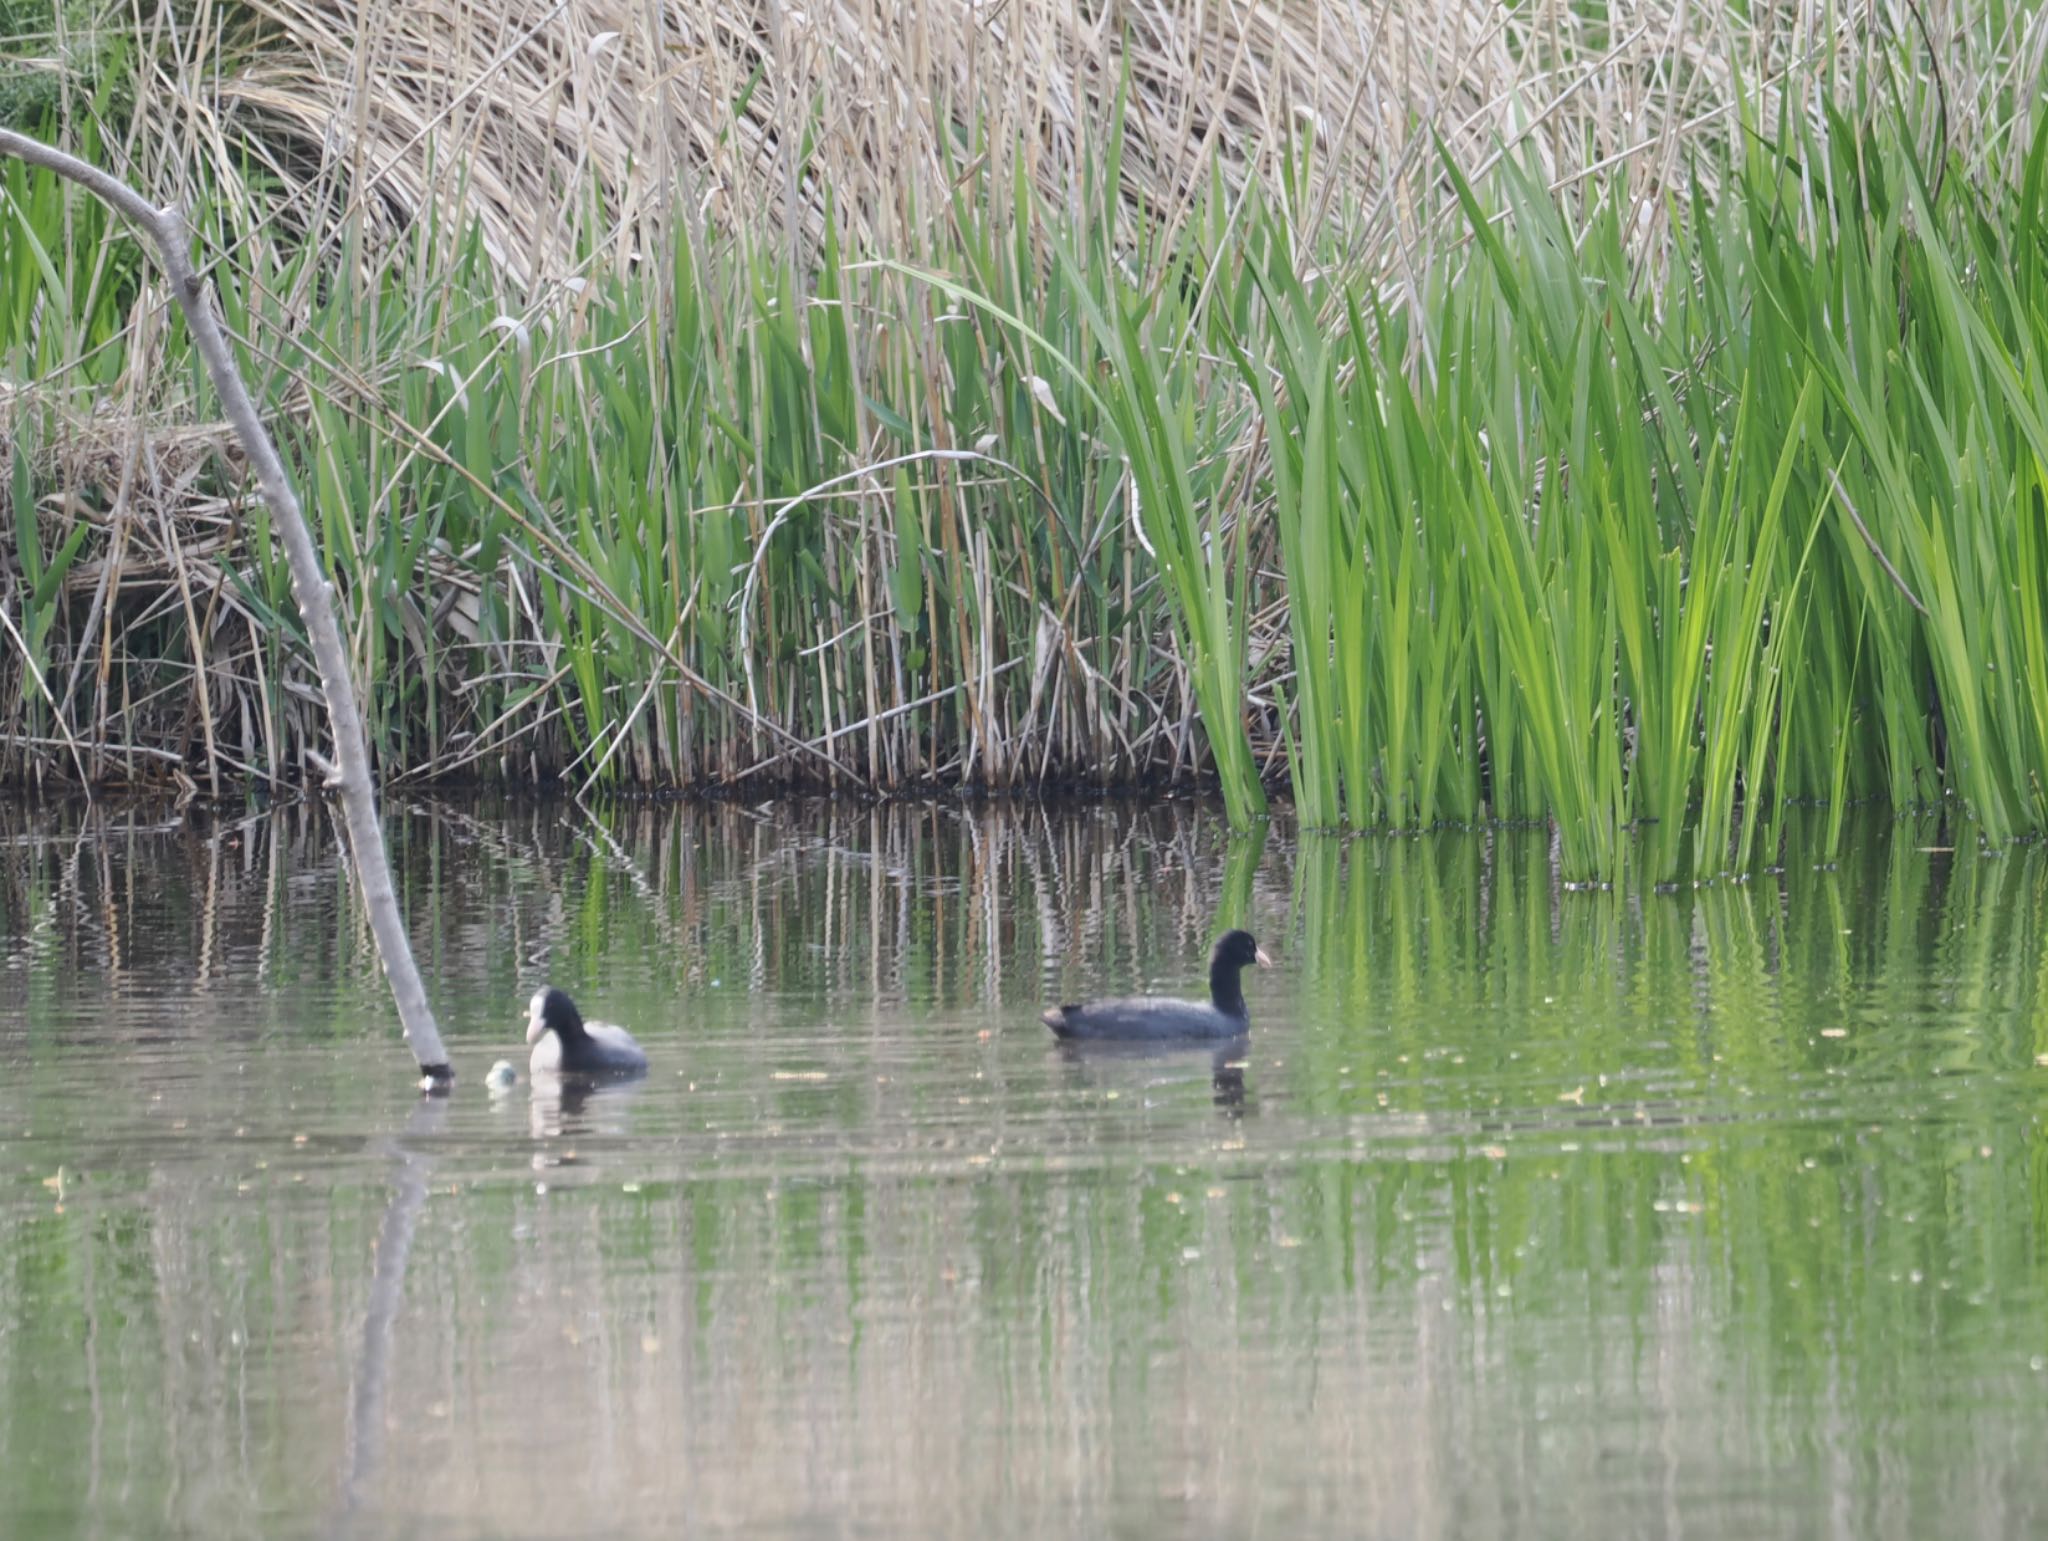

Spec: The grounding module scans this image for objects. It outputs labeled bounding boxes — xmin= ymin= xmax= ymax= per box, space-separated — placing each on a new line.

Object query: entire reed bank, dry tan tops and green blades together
xmin=0 ymin=2 xmax=2048 ymax=883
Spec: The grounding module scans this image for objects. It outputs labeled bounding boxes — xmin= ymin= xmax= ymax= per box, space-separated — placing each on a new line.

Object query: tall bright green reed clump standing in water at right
xmin=1235 ymin=102 xmax=2048 ymax=881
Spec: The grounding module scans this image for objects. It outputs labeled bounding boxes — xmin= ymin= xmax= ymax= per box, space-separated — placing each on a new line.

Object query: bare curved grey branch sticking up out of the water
xmin=0 ymin=129 xmax=455 ymax=1080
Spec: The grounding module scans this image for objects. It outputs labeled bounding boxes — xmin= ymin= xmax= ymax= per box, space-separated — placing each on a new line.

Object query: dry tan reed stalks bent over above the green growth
xmin=79 ymin=0 xmax=2015 ymax=279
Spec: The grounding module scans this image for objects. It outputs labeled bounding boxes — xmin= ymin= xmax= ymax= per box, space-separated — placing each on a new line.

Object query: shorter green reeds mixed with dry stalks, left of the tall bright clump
xmin=6 ymin=114 xmax=1243 ymax=789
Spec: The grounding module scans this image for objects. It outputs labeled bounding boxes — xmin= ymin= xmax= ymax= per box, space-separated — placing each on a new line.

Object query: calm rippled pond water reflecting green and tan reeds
xmin=0 ymin=803 xmax=2048 ymax=1537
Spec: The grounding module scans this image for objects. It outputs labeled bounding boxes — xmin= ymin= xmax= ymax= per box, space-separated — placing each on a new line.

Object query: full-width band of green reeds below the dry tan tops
xmin=0 ymin=9 xmax=2048 ymax=881
